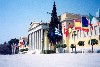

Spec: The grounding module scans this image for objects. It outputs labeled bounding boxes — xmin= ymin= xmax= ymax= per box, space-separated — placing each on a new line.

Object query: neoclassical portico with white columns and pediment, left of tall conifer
xmin=28 ymin=22 xmax=49 ymax=51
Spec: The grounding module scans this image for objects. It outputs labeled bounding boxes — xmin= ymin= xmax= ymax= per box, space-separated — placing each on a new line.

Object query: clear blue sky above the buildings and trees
xmin=0 ymin=0 xmax=100 ymax=43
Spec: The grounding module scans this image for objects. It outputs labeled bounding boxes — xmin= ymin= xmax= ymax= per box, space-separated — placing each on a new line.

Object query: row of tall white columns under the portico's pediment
xmin=29 ymin=29 xmax=43 ymax=50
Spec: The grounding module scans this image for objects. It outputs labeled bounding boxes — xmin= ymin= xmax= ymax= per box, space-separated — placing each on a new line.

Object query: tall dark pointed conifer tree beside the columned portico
xmin=48 ymin=2 xmax=62 ymax=44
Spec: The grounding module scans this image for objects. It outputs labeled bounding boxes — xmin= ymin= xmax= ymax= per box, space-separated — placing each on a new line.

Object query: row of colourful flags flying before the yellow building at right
xmin=64 ymin=14 xmax=99 ymax=37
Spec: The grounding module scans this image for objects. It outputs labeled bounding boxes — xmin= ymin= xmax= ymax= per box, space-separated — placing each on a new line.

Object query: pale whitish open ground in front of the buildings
xmin=0 ymin=53 xmax=100 ymax=67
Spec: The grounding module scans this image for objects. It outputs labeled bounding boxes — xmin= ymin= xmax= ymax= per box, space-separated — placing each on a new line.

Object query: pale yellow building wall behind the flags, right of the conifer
xmin=61 ymin=13 xmax=100 ymax=52
